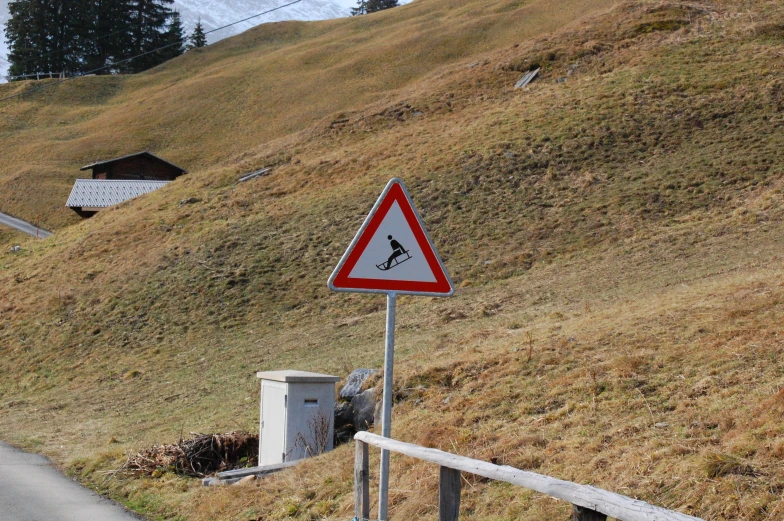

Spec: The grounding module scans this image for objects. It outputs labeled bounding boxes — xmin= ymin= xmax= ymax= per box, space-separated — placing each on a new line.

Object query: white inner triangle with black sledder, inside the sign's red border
xmin=349 ymin=201 xmax=436 ymax=282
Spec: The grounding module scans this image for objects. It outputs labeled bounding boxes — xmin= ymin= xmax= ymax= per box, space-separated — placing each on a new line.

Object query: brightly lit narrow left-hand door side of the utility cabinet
xmin=259 ymin=381 xmax=286 ymax=466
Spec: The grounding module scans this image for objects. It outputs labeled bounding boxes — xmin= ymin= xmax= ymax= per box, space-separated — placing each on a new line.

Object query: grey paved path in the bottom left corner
xmin=0 ymin=442 xmax=141 ymax=521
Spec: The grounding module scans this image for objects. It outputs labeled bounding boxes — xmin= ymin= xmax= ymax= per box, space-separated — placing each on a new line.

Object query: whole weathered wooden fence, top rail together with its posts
xmin=354 ymin=432 xmax=703 ymax=521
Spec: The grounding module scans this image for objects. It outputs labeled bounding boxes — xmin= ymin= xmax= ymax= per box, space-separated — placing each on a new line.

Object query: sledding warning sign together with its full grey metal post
xmin=329 ymin=179 xmax=454 ymax=521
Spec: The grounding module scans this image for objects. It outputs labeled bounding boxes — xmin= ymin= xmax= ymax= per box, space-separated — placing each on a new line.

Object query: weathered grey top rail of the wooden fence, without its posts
xmin=354 ymin=432 xmax=704 ymax=521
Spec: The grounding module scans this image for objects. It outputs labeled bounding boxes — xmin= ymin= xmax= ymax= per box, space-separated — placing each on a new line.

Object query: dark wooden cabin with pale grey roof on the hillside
xmin=65 ymin=152 xmax=187 ymax=218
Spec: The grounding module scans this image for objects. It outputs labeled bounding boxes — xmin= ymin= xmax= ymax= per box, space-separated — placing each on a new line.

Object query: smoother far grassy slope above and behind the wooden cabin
xmin=0 ymin=0 xmax=615 ymax=228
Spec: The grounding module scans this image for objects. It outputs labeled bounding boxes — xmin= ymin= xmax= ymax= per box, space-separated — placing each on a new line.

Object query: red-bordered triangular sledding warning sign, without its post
xmin=329 ymin=179 xmax=454 ymax=297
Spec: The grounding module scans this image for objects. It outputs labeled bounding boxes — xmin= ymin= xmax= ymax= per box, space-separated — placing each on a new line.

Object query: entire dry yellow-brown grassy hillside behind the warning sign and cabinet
xmin=0 ymin=0 xmax=784 ymax=521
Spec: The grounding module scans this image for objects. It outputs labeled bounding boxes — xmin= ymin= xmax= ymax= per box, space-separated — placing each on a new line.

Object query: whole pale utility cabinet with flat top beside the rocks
xmin=256 ymin=370 xmax=340 ymax=467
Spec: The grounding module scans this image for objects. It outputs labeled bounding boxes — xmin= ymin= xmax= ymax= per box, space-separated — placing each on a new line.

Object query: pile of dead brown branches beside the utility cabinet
xmin=121 ymin=432 xmax=259 ymax=477
